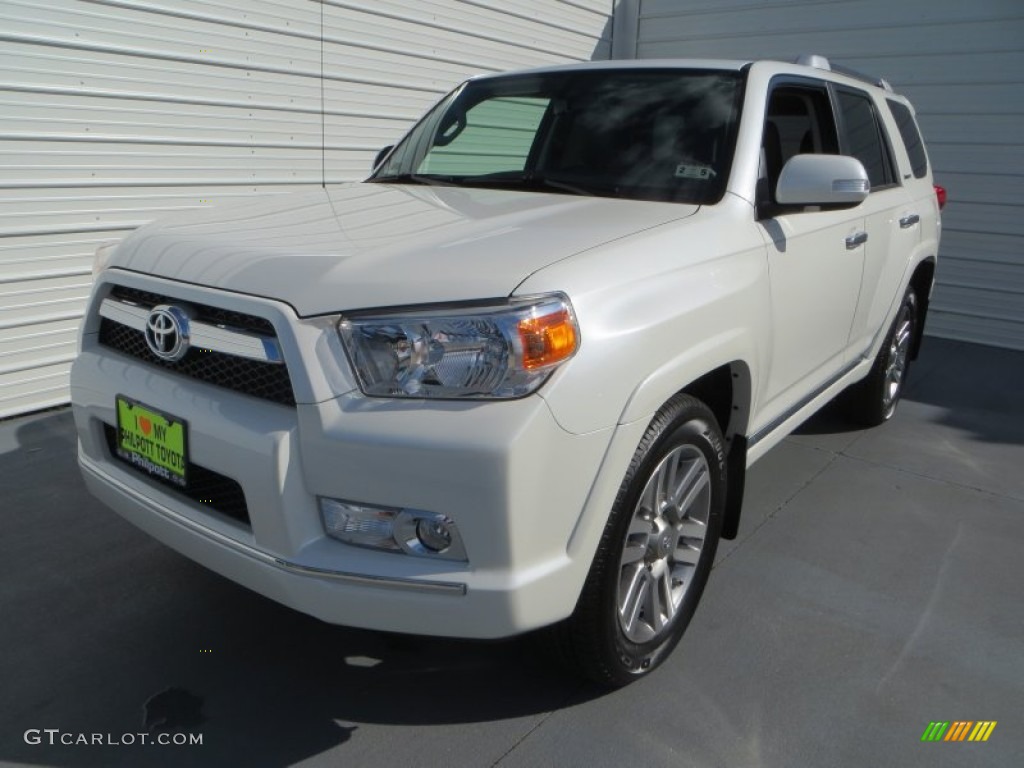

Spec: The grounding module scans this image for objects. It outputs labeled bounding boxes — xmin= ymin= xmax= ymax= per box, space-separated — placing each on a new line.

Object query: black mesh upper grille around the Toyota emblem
xmin=99 ymin=286 xmax=295 ymax=406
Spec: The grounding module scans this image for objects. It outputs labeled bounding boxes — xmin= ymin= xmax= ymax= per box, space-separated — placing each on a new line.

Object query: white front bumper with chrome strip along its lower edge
xmin=72 ymin=276 xmax=621 ymax=638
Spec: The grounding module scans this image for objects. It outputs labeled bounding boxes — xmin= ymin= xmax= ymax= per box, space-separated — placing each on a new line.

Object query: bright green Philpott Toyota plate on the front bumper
xmin=116 ymin=395 xmax=188 ymax=486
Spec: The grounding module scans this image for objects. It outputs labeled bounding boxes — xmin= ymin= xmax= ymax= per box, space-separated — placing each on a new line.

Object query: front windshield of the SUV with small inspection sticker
xmin=369 ymin=70 xmax=740 ymax=204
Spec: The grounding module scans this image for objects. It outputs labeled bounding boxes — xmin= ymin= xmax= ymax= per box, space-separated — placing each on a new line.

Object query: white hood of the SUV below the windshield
xmin=110 ymin=183 xmax=697 ymax=315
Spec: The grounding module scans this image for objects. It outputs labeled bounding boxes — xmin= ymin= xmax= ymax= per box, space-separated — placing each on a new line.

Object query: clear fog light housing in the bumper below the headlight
xmin=319 ymin=498 xmax=466 ymax=560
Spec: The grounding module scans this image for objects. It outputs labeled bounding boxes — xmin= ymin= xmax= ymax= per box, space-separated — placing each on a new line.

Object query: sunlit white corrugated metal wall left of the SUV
xmin=0 ymin=0 xmax=611 ymax=417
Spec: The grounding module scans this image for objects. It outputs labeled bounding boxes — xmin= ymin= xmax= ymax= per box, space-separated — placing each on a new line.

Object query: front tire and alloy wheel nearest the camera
xmin=552 ymin=394 xmax=726 ymax=687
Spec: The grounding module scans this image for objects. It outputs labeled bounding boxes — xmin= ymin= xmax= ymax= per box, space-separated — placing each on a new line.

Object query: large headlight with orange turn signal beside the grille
xmin=339 ymin=294 xmax=580 ymax=398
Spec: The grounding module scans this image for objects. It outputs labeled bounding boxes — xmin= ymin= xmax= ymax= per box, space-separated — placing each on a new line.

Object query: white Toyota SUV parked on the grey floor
xmin=72 ymin=56 xmax=944 ymax=684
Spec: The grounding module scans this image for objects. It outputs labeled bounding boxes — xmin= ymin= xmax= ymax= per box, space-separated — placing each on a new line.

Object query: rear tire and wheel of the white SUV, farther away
xmin=846 ymin=288 xmax=918 ymax=427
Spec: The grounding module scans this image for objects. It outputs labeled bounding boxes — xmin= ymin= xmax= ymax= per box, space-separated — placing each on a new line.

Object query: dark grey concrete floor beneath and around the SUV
xmin=0 ymin=339 xmax=1024 ymax=768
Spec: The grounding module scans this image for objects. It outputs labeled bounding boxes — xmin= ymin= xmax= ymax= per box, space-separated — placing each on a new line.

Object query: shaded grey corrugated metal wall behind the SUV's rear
xmin=633 ymin=0 xmax=1024 ymax=349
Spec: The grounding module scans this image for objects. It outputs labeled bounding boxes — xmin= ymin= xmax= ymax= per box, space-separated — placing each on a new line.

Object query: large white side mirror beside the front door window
xmin=775 ymin=155 xmax=871 ymax=208
